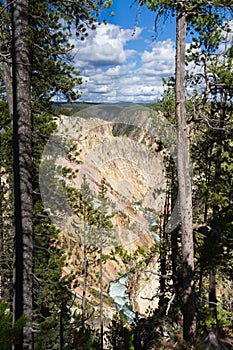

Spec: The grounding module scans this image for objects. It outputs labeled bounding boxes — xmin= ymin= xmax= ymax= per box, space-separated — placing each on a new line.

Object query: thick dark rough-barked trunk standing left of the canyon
xmin=12 ymin=0 xmax=33 ymax=350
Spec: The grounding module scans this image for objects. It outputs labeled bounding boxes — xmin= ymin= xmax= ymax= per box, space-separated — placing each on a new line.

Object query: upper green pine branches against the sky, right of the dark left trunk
xmin=28 ymin=0 xmax=81 ymax=111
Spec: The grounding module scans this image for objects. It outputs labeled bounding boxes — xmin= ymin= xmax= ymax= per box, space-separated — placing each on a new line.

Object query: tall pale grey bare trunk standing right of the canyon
xmin=176 ymin=2 xmax=196 ymax=344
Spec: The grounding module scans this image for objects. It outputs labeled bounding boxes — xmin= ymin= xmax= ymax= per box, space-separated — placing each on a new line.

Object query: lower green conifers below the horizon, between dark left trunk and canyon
xmin=32 ymin=112 xmax=76 ymax=349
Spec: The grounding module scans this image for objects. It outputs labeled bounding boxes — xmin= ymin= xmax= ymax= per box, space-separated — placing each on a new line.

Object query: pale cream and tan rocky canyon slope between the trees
xmin=41 ymin=104 xmax=166 ymax=326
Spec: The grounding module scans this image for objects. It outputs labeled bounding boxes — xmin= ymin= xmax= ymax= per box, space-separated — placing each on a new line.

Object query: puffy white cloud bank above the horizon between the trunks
xmin=70 ymin=24 xmax=175 ymax=102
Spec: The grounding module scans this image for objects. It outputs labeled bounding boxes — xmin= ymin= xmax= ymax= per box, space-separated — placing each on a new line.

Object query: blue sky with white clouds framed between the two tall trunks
xmin=71 ymin=0 xmax=175 ymax=103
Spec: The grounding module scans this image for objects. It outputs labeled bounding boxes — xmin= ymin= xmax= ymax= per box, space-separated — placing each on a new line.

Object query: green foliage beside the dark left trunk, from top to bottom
xmin=0 ymin=0 xmax=116 ymax=349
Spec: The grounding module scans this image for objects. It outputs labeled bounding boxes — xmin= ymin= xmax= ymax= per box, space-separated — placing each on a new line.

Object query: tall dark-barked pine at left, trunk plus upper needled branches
xmin=0 ymin=0 xmax=112 ymax=347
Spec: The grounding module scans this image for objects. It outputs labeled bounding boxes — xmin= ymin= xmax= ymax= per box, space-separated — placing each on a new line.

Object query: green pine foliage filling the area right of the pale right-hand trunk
xmin=140 ymin=1 xmax=232 ymax=342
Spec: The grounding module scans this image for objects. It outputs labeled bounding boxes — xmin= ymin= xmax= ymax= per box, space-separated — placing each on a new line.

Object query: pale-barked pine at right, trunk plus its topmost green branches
xmin=138 ymin=0 xmax=230 ymax=343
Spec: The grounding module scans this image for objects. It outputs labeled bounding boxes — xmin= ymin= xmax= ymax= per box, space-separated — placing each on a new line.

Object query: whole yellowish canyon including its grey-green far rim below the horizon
xmin=40 ymin=106 xmax=171 ymax=324
